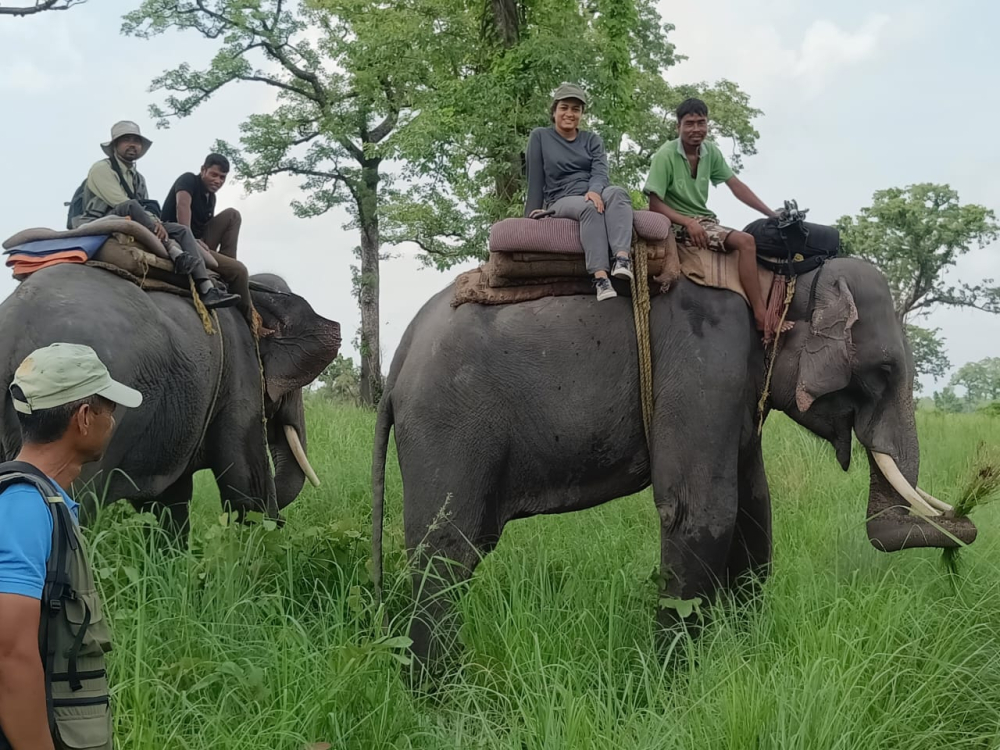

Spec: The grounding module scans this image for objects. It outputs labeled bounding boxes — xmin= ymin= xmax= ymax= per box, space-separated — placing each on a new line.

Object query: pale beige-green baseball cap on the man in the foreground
xmin=11 ymin=344 xmax=142 ymax=414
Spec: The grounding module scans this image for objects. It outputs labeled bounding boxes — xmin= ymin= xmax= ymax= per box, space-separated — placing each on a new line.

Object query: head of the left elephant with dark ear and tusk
xmin=251 ymin=274 xmax=340 ymax=509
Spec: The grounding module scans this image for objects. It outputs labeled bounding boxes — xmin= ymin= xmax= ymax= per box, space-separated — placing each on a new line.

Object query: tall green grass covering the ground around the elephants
xmin=80 ymin=403 xmax=1000 ymax=750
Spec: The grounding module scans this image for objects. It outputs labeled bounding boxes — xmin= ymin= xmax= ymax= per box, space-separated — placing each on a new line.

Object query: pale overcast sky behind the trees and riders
xmin=0 ymin=0 xmax=1000 ymax=390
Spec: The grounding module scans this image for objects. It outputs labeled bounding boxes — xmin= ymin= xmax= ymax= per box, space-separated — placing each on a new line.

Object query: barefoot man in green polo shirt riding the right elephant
xmin=643 ymin=99 xmax=777 ymax=333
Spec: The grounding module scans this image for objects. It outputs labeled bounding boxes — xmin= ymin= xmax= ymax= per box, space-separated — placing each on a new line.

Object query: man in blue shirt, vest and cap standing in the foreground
xmin=0 ymin=344 xmax=142 ymax=750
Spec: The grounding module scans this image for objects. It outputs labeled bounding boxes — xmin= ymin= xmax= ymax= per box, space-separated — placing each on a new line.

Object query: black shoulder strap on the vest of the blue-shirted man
xmin=0 ymin=461 xmax=76 ymax=733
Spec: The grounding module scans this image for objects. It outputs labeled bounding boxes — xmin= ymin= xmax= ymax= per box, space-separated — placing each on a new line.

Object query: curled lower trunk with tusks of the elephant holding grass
xmin=858 ymin=400 xmax=977 ymax=552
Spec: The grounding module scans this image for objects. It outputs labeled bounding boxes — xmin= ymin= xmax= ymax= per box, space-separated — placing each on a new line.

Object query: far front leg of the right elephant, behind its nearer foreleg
xmin=726 ymin=439 xmax=771 ymax=595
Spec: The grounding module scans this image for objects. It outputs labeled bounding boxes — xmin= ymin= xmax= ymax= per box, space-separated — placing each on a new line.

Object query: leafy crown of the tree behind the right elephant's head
xmin=837 ymin=183 xmax=1000 ymax=320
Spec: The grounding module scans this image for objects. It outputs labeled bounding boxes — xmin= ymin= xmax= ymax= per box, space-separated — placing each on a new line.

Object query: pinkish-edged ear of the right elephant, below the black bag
xmin=795 ymin=278 xmax=858 ymax=412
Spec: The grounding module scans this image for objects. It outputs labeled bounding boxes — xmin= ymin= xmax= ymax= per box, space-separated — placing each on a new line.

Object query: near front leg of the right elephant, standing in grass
xmin=652 ymin=415 xmax=739 ymax=629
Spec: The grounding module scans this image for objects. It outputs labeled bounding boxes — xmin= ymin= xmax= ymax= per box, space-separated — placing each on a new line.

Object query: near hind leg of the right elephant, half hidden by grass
xmin=404 ymin=482 xmax=500 ymax=682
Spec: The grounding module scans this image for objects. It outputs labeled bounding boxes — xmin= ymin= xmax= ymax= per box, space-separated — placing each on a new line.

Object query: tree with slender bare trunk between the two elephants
xmin=123 ymin=0 xmax=450 ymax=404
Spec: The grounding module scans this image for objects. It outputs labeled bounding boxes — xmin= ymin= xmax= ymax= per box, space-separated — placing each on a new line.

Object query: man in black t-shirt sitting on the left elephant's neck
xmin=163 ymin=154 xmax=268 ymax=335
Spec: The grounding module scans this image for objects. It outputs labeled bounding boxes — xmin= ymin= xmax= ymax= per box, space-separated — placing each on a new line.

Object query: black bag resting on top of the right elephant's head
xmin=743 ymin=201 xmax=840 ymax=278
